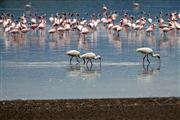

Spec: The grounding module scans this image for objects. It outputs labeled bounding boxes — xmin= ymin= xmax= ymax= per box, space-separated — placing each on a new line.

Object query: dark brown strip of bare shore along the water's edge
xmin=0 ymin=97 xmax=180 ymax=120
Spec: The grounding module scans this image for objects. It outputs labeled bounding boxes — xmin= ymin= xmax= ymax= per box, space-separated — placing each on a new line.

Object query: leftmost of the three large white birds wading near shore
xmin=66 ymin=50 xmax=80 ymax=65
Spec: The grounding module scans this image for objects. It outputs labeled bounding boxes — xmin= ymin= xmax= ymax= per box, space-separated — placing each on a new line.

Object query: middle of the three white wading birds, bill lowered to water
xmin=80 ymin=52 xmax=101 ymax=65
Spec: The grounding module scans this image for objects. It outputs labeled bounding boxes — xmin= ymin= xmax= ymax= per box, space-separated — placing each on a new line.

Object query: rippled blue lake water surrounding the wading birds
xmin=0 ymin=0 xmax=180 ymax=100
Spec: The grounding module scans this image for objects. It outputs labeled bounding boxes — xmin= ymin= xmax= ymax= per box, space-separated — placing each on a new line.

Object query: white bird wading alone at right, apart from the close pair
xmin=136 ymin=47 xmax=160 ymax=65
